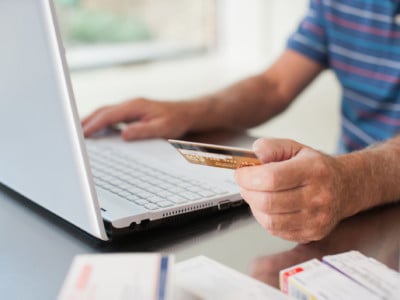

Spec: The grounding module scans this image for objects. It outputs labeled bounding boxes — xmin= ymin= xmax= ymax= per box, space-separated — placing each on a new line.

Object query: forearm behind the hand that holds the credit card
xmin=338 ymin=137 xmax=400 ymax=217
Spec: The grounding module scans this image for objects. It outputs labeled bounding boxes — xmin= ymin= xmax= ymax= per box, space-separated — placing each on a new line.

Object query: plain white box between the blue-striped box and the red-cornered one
xmin=174 ymin=256 xmax=289 ymax=300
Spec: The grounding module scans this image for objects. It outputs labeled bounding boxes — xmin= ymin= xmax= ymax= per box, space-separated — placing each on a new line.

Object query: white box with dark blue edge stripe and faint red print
xmin=58 ymin=254 xmax=173 ymax=300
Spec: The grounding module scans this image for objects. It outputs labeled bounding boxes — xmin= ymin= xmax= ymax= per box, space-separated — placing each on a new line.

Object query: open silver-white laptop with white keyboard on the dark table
xmin=0 ymin=0 xmax=243 ymax=241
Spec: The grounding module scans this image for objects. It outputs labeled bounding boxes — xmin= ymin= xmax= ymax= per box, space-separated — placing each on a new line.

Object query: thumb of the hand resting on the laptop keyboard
xmin=121 ymin=121 xmax=166 ymax=140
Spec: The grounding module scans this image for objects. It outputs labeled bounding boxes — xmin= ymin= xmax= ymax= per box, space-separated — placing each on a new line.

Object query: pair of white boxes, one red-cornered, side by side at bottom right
xmin=279 ymin=251 xmax=400 ymax=300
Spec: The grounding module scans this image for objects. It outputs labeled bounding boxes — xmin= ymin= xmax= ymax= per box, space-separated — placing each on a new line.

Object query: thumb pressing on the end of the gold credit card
xmin=253 ymin=138 xmax=305 ymax=163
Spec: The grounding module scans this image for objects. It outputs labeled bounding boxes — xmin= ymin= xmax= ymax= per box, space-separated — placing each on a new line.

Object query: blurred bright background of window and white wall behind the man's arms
xmin=55 ymin=0 xmax=340 ymax=152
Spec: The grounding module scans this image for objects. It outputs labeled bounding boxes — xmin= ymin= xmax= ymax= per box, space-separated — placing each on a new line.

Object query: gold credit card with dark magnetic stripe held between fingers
xmin=168 ymin=140 xmax=261 ymax=169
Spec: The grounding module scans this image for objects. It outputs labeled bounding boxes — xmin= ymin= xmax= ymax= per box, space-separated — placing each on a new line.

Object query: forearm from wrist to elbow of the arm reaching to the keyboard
xmin=186 ymin=75 xmax=290 ymax=131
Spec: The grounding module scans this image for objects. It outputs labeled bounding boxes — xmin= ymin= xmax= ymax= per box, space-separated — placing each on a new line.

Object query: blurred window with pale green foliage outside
xmin=56 ymin=0 xmax=217 ymax=69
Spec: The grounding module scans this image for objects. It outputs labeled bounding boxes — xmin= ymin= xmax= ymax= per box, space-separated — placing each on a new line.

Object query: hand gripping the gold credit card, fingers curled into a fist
xmin=235 ymin=139 xmax=347 ymax=243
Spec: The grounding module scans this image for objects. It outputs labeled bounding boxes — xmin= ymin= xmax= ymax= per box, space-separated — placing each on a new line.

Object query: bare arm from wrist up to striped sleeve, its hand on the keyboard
xmin=183 ymin=50 xmax=324 ymax=131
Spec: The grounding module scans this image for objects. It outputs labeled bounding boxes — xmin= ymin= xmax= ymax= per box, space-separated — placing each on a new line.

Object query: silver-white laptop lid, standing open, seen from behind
xmin=0 ymin=0 xmax=107 ymax=240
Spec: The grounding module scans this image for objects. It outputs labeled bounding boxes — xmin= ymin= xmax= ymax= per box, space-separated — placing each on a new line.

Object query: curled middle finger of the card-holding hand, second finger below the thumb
xmin=240 ymin=187 xmax=305 ymax=214
